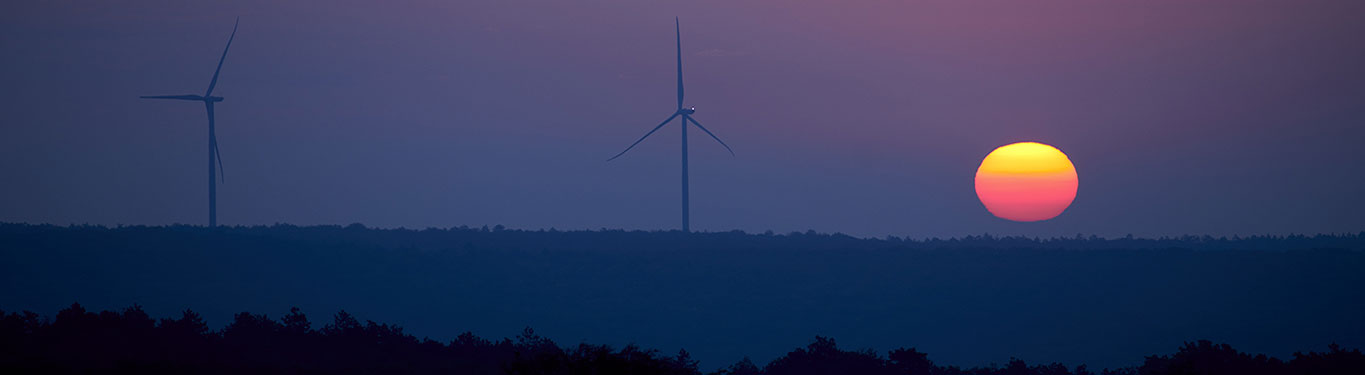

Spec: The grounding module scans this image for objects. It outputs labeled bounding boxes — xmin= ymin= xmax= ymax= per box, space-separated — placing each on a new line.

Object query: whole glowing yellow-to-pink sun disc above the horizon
xmin=976 ymin=142 xmax=1078 ymax=221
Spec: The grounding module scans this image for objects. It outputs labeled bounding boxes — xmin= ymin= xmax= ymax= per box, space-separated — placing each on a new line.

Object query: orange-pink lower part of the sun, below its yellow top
xmin=976 ymin=170 xmax=1077 ymax=221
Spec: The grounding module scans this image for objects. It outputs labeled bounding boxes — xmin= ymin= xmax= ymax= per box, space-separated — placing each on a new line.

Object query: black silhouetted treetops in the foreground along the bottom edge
xmin=0 ymin=304 xmax=1365 ymax=375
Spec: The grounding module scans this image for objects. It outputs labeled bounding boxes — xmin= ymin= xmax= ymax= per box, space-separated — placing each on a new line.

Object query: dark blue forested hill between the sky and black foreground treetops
xmin=0 ymin=225 xmax=1365 ymax=368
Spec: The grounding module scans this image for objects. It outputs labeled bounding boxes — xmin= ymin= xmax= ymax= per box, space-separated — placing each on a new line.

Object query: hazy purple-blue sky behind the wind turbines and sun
xmin=0 ymin=0 xmax=1365 ymax=237
